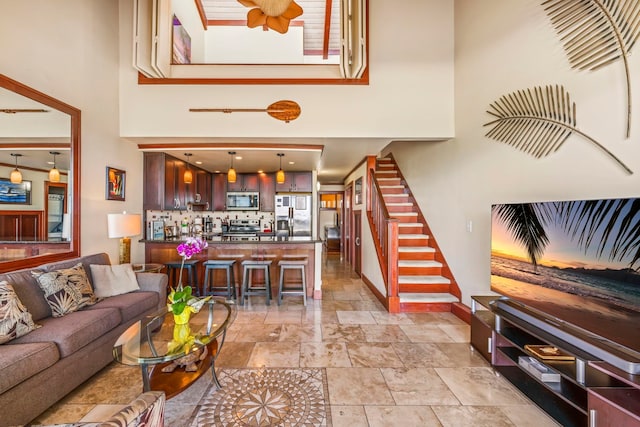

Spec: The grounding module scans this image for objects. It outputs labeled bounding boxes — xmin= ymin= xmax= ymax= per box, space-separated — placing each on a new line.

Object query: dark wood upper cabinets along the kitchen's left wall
xmin=142 ymin=153 xmax=211 ymax=210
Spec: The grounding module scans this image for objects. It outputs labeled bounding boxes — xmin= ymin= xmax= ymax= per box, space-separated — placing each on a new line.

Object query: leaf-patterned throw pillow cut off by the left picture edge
xmin=0 ymin=280 xmax=39 ymax=344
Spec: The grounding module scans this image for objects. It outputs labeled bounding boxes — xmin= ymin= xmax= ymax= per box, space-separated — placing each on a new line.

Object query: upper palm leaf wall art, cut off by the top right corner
xmin=542 ymin=0 xmax=640 ymax=138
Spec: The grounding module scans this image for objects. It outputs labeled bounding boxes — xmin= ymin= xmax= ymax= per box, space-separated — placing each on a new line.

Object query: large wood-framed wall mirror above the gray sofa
xmin=0 ymin=74 xmax=80 ymax=272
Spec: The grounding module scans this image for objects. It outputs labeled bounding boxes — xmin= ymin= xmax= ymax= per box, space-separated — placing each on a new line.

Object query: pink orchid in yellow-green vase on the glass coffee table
xmin=167 ymin=237 xmax=211 ymax=324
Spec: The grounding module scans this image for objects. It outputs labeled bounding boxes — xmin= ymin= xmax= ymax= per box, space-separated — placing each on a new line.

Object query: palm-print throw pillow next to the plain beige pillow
xmin=32 ymin=263 xmax=98 ymax=317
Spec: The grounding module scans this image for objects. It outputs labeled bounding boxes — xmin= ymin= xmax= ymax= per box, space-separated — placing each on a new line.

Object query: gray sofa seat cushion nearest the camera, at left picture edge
xmin=0 ymin=341 xmax=60 ymax=393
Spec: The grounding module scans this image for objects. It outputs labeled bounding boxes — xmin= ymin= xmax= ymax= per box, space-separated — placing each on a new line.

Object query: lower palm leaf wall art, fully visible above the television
xmin=484 ymin=85 xmax=633 ymax=174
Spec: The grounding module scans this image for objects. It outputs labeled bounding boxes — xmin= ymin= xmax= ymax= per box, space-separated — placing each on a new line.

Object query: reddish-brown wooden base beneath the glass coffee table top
xmin=142 ymin=340 xmax=220 ymax=399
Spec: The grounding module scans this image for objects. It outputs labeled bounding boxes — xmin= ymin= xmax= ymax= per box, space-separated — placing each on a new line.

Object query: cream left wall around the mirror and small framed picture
xmin=0 ymin=0 xmax=144 ymax=263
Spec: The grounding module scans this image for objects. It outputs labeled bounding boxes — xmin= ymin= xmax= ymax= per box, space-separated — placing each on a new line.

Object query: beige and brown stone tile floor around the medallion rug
xmin=36 ymin=256 xmax=557 ymax=427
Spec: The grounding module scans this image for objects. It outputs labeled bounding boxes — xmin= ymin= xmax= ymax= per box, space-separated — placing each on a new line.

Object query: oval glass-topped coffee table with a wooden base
xmin=113 ymin=298 xmax=237 ymax=399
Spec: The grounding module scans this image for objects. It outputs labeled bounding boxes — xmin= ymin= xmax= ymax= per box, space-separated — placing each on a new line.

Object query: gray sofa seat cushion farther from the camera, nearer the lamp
xmin=11 ymin=308 xmax=122 ymax=358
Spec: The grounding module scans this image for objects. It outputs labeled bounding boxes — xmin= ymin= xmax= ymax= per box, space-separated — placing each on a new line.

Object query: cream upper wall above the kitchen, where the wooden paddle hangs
xmin=120 ymin=0 xmax=454 ymax=140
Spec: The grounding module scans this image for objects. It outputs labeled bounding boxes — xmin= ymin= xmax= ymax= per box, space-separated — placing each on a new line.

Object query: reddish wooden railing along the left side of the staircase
xmin=367 ymin=159 xmax=399 ymax=312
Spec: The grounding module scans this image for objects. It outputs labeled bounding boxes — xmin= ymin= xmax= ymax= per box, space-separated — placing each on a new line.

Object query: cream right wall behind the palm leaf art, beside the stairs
xmin=384 ymin=0 xmax=640 ymax=304
